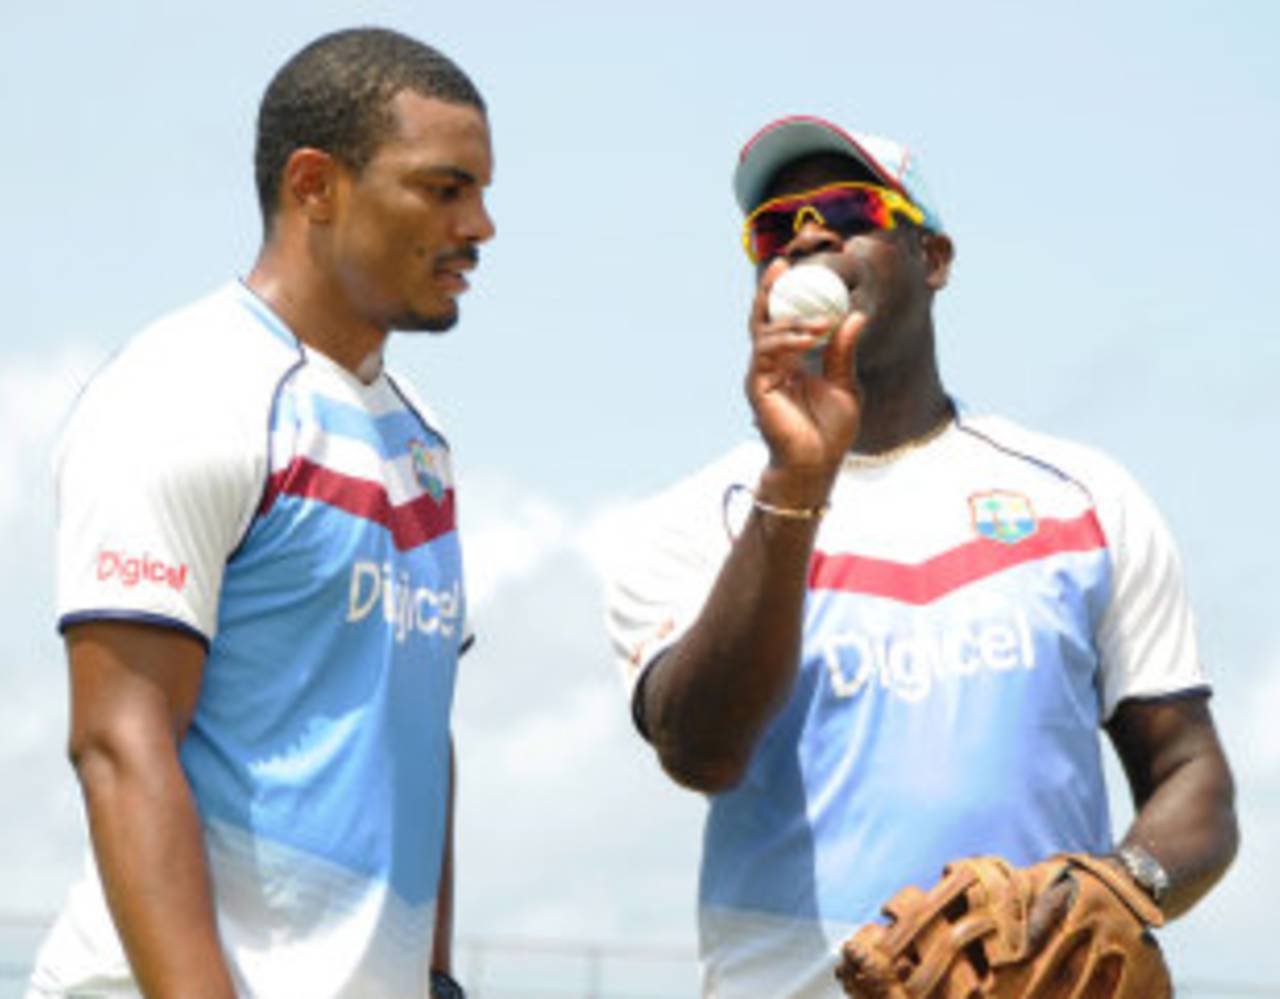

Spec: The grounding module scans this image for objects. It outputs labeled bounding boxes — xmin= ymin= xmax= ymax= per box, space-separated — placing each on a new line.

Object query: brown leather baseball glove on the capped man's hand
xmin=836 ymin=853 xmax=1172 ymax=999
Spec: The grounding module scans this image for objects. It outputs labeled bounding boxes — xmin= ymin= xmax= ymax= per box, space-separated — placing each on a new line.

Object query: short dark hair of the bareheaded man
xmin=253 ymin=28 xmax=485 ymax=232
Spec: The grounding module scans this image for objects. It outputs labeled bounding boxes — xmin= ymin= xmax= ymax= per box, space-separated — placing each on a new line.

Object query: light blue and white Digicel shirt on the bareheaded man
xmin=35 ymin=283 xmax=467 ymax=999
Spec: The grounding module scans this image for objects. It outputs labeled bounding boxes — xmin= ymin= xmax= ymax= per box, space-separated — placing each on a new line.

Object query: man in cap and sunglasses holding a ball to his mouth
xmin=608 ymin=117 xmax=1238 ymax=999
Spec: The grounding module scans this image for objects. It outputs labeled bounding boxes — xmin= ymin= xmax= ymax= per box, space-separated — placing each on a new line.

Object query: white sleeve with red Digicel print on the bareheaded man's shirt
xmin=55 ymin=284 xmax=298 ymax=640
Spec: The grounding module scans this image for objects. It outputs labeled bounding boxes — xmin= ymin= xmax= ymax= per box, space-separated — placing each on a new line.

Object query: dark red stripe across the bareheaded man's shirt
xmin=259 ymin=459 xmax=454 ymax=552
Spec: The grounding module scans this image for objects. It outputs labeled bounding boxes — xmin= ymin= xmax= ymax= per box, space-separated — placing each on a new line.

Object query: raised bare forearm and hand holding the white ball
xmin=639 ymin=264 xmax=864 ymax=792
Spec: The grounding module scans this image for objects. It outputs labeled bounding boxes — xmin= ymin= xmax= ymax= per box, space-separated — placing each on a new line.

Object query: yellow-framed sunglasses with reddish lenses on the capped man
xmin=742 ymin=181 xmax=924 ymax=264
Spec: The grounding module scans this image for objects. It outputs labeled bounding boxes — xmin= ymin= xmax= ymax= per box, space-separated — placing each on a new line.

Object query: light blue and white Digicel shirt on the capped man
xmin=609 ymin=418 xmax=1206 ymax=999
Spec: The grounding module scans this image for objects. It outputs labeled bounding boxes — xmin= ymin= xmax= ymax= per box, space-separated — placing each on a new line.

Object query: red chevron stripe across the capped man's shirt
xmin=809 ymin=510 xmax=1106 ymax=605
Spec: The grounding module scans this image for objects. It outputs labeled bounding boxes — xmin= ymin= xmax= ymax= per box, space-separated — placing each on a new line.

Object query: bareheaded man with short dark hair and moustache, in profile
xmin=29 ymin=28 xmax=494 ymax=999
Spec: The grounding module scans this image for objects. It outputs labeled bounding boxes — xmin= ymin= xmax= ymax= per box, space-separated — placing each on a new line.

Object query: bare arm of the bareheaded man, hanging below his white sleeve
xmin=67 ymin=621 xmax=234 ymax=999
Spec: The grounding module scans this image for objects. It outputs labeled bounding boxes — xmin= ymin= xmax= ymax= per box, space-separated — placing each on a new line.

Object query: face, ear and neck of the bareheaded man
xmin=248 ymin=91 xmax=494 ymax=375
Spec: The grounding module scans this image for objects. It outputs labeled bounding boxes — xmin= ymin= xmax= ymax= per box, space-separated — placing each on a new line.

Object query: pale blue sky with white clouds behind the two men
xmin=0 ymin=0 xmax=1280 ymax=982
